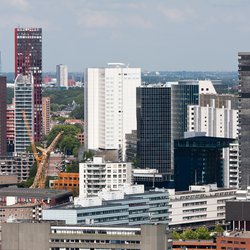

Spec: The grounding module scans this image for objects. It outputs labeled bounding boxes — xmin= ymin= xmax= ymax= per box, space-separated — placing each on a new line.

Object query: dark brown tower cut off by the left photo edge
xmin=0 ymin=76 xmax=7 ymax=156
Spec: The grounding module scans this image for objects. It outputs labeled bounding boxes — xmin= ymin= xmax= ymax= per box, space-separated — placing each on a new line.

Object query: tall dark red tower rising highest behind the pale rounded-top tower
xmin=15 ymin=28 xmax=42 ymax=142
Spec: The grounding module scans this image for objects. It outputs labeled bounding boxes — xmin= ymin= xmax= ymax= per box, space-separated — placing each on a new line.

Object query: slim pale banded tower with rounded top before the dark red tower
xmin=14 ymin=74 xmax=34 ymax=153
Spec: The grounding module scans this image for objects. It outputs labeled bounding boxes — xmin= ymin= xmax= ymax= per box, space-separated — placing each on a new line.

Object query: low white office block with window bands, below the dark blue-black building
xmin=168 ymin=184 xmax=237 ymax=228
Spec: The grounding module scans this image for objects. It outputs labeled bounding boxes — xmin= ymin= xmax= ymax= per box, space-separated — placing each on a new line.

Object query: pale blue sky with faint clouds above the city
xmin=0 ymin=0 xmax=250 ymax=72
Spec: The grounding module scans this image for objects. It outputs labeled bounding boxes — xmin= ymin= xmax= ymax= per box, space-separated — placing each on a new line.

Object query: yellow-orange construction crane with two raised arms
xmin=22 ymin=111 xmax=63 ymax=188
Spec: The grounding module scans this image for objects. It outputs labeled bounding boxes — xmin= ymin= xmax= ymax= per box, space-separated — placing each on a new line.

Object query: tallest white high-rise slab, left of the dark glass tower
xmin=84 ymin=63 xmax=141 ymax=160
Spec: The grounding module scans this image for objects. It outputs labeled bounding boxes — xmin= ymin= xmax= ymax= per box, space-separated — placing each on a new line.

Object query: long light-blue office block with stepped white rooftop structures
xmin=43 ymin=185 xmax=168 ymax=227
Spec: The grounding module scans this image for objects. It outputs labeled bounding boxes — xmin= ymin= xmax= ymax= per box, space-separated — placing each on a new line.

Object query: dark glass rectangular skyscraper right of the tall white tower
xmin=137 ymin=85 xmax=172 ymax=187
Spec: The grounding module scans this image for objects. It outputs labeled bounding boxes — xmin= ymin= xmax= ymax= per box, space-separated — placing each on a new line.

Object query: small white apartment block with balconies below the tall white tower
xmin=79 ymin=157 xmax=132 ymax=197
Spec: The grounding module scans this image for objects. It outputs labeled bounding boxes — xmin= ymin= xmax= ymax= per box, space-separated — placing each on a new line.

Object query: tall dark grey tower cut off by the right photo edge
xmin=238 ymin=52 xmax=250 ymax=189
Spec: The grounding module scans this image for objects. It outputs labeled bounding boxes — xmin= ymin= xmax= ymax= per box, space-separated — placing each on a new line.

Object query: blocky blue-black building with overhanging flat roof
xmin=174 ymin=136 xmax=234 ymax=191
